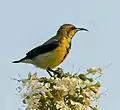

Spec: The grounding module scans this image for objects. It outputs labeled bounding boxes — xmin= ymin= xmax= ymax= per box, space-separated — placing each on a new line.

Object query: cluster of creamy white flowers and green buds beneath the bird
xmin=18 ymin=67 xmax=103 ymax=110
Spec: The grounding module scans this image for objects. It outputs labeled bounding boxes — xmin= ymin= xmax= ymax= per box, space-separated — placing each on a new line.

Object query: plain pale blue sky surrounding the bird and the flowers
xmin=0 ymin=0 xmax=120 ymax=110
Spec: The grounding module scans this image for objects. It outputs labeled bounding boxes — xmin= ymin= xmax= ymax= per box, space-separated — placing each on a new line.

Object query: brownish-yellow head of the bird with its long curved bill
xmin=57 ymin=24 xmax=88 ymax=38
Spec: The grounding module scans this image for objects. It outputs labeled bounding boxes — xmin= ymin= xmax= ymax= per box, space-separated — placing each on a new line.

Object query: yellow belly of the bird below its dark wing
xmin=33 ymin=46 xmax=67 ymax=69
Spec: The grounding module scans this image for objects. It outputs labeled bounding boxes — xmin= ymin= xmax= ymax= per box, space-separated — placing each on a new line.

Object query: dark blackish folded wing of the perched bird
xmin=26 ymin=40 xmax=59 ymax=59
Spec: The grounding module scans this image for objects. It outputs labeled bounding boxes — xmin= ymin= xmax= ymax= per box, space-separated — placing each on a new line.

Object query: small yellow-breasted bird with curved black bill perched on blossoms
xmin=12 ymin=24 xmax=88 ymax=76
